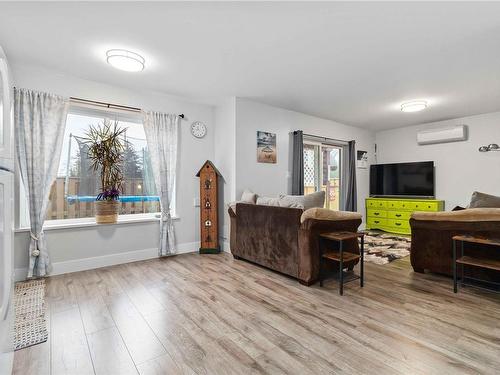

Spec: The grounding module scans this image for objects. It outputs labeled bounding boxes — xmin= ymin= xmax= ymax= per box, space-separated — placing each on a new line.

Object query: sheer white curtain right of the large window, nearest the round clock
xmin=143 ymin=111 xmax=179 ymax=256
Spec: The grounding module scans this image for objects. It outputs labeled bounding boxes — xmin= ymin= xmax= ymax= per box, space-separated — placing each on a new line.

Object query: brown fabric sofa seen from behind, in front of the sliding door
xmin=228 ymin=203 xmax=361 ymax=285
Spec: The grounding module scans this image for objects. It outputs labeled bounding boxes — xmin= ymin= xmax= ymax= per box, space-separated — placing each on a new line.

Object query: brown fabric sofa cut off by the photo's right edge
xmin=410 ymin=208 xmax=500 ymax=280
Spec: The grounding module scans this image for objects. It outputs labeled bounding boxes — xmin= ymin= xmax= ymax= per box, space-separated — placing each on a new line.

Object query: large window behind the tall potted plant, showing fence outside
xmin=20 ymin=106 xmax=160 ymax=226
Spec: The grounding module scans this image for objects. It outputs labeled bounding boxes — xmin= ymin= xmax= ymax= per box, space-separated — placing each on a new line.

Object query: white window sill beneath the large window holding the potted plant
xmin=14 ymin=214 xmax=180 ymax=233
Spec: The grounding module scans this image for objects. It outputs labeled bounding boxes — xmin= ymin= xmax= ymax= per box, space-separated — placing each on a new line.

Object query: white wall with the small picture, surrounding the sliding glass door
xmin=236 ymin=98 xmax=375 ymax=216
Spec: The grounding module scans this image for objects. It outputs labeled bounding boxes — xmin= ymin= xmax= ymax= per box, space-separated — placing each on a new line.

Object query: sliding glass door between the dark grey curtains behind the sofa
xmin=304 ymin=141 xmax=342 ymax=210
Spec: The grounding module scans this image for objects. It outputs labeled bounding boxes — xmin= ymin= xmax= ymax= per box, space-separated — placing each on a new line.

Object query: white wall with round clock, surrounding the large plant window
xmin=12 ymin=65 xmax=215 ymax=278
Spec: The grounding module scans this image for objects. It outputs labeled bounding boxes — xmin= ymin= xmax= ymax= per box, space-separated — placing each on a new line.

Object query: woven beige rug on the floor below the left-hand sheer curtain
xmin=14 ymin=279 xmax=49 ymax=350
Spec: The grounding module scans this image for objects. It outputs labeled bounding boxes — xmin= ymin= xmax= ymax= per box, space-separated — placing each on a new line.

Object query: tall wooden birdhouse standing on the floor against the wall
xmin=196 ymin=160 xmax=221 ymax=254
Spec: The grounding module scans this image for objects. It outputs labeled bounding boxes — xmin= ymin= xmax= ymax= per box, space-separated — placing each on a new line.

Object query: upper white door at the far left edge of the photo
xmin=0 ymin=47 xmax=13 ymax=169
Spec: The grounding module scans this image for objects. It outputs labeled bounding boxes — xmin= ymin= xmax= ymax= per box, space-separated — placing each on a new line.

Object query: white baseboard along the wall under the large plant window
xmin=14 ymin=242 xmax=200 ymax=281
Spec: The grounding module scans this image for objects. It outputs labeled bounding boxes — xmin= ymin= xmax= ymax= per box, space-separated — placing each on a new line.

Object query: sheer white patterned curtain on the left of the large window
xmin=14 ymin=88 xmax=69 ymax=278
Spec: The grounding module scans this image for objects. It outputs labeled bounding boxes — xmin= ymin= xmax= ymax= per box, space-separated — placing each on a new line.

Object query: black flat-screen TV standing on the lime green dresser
xmin=370 ymin=161 xmax=434 ymax=197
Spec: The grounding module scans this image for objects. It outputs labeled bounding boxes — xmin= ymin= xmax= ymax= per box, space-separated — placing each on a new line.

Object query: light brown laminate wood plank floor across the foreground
xmin=14 ymin=254 xmax=500 ymax=375
